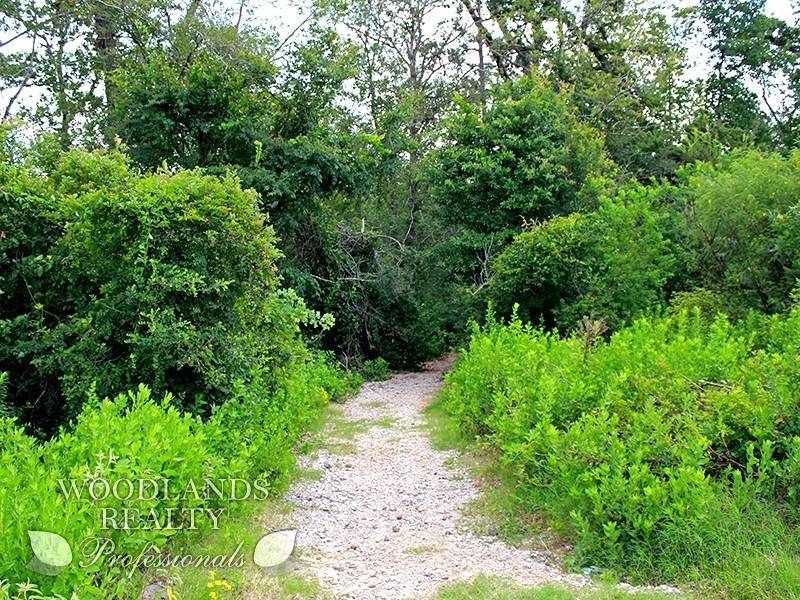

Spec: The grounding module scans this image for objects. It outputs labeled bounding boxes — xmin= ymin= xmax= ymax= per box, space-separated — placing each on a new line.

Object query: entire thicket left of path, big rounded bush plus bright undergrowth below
xmin=0 ymin=150 xmax=351 ymax=598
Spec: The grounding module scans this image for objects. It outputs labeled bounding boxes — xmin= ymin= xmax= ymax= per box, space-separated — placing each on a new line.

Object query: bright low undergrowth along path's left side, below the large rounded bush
xmin=0 ymin=359 xmax=346 ymax=598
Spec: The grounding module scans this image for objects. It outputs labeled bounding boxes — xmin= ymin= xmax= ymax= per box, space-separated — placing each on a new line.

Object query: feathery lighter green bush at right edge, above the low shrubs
xmin=683 ymin=152 xmax=800 ymax=312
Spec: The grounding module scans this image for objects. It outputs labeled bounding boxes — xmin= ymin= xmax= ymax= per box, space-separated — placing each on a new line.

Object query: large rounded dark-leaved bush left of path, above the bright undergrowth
xmin=0 ymin=151 xmax=318 ymax=433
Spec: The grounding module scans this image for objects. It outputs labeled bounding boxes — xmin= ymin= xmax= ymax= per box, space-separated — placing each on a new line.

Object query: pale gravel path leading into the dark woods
xmin=289 ymin=362 xmax=586 ymax=600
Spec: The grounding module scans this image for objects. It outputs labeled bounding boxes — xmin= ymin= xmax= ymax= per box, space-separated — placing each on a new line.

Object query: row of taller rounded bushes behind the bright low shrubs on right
xmin=486 ymin=151 xmax=800 ymax=331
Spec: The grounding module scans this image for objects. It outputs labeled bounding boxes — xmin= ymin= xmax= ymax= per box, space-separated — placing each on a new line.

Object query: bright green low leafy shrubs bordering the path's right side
xmin=444 ymin=308 xmax=800 ymax=584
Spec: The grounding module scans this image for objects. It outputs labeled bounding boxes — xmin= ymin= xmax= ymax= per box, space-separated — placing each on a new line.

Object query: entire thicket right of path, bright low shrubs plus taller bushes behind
xmin=443 ymin=151 xmax=800 ymax=598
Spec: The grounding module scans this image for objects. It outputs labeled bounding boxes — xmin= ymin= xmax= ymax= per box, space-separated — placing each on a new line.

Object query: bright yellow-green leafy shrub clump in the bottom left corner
xmin=0 ymin=387 xmax=213 ymax=598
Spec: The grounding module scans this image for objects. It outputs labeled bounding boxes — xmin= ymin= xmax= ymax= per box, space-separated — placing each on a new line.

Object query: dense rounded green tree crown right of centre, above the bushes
xmin=430 ymin=77 xmax=608 ymax=233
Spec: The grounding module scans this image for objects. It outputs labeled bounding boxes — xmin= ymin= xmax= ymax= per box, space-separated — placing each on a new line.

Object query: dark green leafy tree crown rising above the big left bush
xmin=115 ymin=51 xmax=275 ymax=168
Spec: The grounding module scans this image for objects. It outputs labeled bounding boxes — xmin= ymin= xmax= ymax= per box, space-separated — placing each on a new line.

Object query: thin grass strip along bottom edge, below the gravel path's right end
xmin=435 ymin=576 xmax=687 ymax=600
